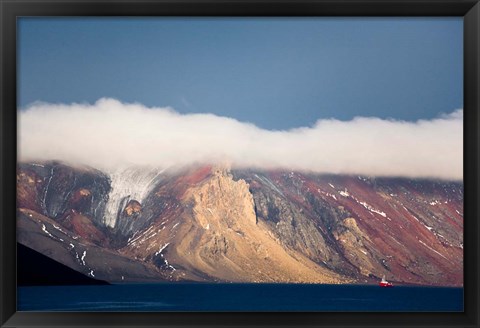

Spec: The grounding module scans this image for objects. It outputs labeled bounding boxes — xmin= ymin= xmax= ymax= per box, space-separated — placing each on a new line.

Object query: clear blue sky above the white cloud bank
xmin=18 ymin=18 xmax=463 ymax=130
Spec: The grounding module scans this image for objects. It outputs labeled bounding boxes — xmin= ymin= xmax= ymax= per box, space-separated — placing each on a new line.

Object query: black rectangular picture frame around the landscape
xmin=0 ymin=0 xmax=480 ymax=327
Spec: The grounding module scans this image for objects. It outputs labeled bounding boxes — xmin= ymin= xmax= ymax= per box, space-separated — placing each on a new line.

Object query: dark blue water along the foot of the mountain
xmin=17 ymin=283 xmax=463 ymax=312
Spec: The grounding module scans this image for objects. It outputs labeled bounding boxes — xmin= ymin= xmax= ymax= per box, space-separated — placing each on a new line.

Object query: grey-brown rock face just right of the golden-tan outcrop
xmin=234 ymin=171 xmax=362 ymax=275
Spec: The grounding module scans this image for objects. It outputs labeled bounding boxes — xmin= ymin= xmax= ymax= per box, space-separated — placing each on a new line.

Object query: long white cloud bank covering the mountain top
xmin=18 ymin=99 xmax=463 ymax=180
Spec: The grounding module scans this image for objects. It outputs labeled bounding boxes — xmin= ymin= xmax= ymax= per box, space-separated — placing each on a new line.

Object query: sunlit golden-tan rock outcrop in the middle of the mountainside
xmin=163 ymin=167 xmax=344 ymax=283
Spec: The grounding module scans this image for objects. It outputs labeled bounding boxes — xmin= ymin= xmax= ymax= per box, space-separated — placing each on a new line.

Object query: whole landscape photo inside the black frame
xmin=17 ymin=17 xmax=464 ymax=312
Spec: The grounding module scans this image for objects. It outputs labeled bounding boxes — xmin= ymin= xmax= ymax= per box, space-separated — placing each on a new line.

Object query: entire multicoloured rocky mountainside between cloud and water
xmin=17 ymin=163 xmax=463 ymax=285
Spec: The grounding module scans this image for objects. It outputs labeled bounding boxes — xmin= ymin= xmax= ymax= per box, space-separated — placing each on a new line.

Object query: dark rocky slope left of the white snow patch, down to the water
xmin=17 ymin=162 xmax=164 ymax=281
